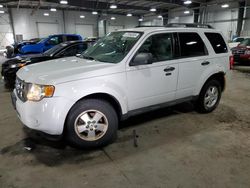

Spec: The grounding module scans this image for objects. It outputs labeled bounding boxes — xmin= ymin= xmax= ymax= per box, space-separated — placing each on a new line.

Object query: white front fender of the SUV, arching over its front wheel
xmin=54 ymin=73 xmax=128 ymax=114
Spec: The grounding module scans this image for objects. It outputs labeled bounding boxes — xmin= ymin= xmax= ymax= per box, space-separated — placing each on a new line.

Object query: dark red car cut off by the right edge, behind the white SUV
xmin=232 ymin=38 xmax=250 ymax=65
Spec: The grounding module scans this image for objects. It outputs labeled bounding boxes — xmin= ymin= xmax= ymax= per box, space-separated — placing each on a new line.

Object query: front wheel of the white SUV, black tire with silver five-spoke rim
xmin=65 ymin=99 xmax=118 ymax=149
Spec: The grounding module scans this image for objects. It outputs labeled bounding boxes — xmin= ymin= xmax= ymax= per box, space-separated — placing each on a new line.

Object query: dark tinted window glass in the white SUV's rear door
xmin=179 ymin=33 xmax=207 ymax=57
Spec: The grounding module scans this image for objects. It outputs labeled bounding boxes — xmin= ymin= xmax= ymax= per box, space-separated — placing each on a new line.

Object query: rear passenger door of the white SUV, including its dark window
xmin=176 ymin=32 xmax=211 ymax=99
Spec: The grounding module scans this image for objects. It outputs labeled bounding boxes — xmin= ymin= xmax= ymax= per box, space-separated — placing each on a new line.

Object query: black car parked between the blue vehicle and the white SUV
xmin=1 ymin=40 xmax=95 ymax=88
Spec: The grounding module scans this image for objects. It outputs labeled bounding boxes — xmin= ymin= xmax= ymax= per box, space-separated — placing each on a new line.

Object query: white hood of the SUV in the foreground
xmin=17 ymin=57 xmax=117 ymax=85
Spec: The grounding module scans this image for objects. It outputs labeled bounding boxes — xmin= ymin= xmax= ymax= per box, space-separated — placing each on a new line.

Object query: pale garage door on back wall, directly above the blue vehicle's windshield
xmin=37 ymin=22 xmax=59 ymax=37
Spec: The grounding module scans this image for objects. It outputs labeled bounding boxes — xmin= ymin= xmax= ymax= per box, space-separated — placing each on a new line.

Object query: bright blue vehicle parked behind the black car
xmin=18 ymin=34 xmax=83 ymax=55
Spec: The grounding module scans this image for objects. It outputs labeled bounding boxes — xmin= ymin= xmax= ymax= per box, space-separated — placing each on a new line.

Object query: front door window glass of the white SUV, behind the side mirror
xmin=138 ymin=33 xmax=173 ymax=62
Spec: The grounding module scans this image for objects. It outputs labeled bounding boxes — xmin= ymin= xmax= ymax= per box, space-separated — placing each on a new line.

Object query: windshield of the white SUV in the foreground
xmin=80 ymin=31 xmax=142 ymax=63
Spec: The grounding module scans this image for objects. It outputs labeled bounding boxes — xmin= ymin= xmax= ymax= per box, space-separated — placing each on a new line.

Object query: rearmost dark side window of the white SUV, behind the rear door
xmin=205 ymin=33 xmax=228 ymax=54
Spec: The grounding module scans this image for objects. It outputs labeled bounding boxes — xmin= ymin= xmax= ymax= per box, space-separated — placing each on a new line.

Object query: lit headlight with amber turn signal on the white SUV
xmin=27 ymin=84 xmax=55 ymax=101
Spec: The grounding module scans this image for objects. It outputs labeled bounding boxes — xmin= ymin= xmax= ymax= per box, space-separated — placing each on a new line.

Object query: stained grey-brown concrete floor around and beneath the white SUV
xmin=0 ymin=58 xmax=250 ymax=188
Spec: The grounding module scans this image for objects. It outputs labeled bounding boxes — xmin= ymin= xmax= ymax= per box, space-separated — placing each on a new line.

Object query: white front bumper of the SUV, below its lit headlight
xmin=11 ymin=90 xmax=72 ymax=135
